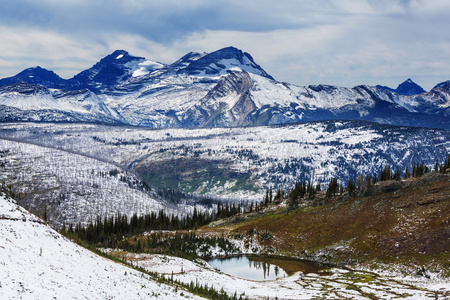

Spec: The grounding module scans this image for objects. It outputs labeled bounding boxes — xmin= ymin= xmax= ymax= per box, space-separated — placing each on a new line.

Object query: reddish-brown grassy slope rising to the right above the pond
xmin=203 ymin=173 xmax=450 ymax=275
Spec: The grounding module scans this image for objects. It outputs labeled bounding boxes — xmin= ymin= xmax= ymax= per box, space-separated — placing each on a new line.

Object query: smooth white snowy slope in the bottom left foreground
xmin=0 ymin=195 xmax=203 ymax=300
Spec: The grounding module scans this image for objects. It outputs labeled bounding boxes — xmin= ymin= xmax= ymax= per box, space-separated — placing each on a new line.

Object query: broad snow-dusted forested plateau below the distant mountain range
xmin=0 ymin=121 xmax=450 ymax=200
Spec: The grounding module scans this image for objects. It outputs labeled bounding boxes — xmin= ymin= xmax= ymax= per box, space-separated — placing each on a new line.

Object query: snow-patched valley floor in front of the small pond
xmin=107 ymin=249 xmax=450 ymax=299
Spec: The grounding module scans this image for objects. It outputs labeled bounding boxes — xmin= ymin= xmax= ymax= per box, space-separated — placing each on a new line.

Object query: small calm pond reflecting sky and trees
xmin=208 ymin=255 xmax=324 ymax=281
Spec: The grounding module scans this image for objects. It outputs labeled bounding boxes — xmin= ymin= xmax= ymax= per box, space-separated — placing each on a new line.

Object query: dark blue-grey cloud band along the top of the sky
xmin=0 ymin=0 xmax=344 ymax=43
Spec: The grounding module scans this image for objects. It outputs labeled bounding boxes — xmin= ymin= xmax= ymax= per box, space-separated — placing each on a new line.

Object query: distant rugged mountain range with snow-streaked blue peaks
xmin=0 ymin=47 xmax=450 ymax=129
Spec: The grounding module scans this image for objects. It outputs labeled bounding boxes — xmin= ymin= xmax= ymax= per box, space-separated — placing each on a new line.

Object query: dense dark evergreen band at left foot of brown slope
xmin=61 ymin=203 xmax=241 ymax=247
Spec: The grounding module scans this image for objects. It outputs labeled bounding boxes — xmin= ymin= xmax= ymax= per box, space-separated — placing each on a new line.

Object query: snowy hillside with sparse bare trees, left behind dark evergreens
xmin=0 ymin=136 xmax=198 ymax=228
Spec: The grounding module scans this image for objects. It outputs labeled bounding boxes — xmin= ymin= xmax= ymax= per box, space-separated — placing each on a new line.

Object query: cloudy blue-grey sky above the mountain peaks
xmin=0 ymin=0 xmax=450 ymax=90
